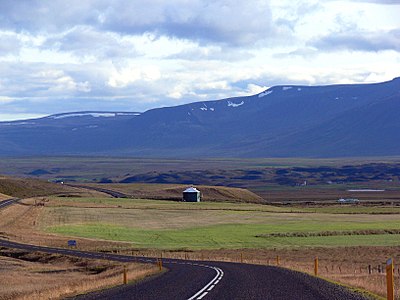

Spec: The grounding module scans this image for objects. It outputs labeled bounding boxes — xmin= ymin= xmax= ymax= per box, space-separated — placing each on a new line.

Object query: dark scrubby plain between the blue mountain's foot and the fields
xmin=0 ymin=157 xmax=400 ymax=205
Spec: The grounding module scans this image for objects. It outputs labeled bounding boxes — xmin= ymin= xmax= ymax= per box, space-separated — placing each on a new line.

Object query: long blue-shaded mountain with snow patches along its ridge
xmin=0 ymin=78 xmax=400 ymax=157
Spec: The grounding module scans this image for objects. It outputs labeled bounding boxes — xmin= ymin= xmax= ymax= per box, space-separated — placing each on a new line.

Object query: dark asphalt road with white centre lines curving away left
xmin=0 ymin=199 xmax=368 ymax=300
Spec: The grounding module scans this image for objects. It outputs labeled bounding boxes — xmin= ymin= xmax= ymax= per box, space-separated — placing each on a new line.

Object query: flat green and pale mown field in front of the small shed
xmin=40 ymin=198 xmax=400 ymax=250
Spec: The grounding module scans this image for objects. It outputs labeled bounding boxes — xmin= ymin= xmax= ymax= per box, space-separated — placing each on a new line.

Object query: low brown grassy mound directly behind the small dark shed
xmin=79 ymin=183 xmax=263 ymax=203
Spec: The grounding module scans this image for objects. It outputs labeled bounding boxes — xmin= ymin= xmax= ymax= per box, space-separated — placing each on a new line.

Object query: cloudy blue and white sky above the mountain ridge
xmin=0 ymin=0 xmax=400 ymax=121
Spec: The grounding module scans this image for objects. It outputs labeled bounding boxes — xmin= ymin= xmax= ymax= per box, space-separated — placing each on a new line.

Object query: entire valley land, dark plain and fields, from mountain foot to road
xmin=0 ymin=158 xmax=400 ymax=295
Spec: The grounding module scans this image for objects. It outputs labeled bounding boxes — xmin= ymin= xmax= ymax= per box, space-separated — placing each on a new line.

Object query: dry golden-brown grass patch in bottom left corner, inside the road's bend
xmin=0 ymin=248 xmax=158 ymax=300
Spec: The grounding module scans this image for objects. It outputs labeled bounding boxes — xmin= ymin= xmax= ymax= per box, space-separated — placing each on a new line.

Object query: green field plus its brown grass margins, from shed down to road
xmin=0 ymin=197 xmax=400 ymax=295
